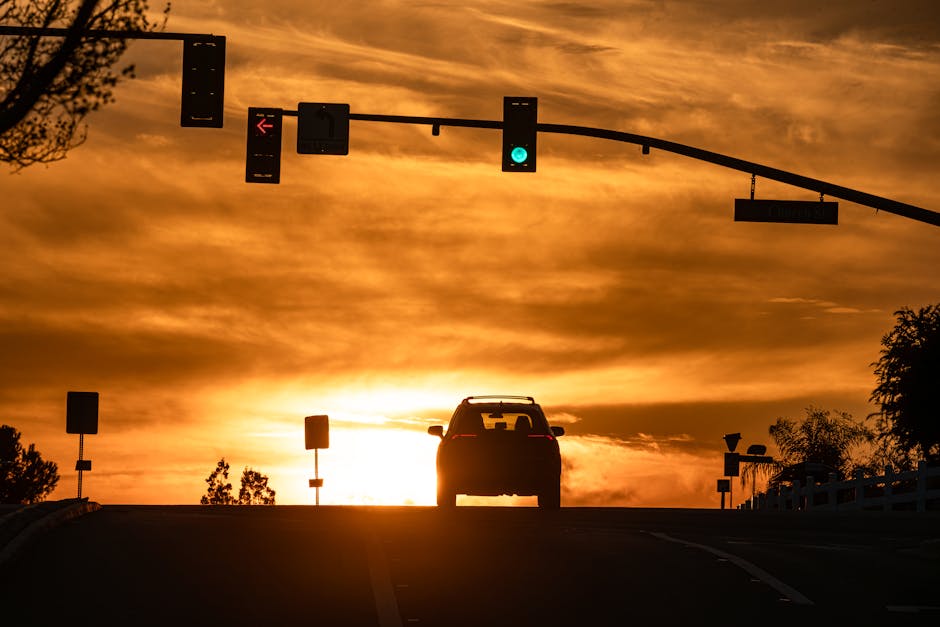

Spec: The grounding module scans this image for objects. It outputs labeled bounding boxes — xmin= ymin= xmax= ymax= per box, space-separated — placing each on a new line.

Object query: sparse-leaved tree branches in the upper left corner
xmin=0 ymin=0 xmax=170 ymax=170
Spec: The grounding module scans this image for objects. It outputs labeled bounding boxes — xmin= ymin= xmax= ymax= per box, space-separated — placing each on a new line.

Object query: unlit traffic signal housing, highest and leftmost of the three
xmin=180 ymin=37 xmax=225 ymax=128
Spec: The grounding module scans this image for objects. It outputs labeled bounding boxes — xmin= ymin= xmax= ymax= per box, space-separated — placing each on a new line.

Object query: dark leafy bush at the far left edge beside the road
xmin=0 ymin=425 xmax=59 ymax=504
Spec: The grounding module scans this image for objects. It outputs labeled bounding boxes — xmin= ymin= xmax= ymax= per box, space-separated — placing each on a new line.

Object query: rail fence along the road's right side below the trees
xmin=738 ymin=461 xmax=940 ymax=512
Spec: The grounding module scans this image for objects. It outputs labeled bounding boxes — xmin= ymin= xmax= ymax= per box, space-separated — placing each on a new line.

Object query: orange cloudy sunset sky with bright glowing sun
xmin=0 ymin=0 xmax=940 ymax=507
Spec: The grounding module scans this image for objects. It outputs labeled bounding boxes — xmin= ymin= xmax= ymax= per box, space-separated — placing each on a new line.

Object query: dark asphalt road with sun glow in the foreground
xmin=0 ymin=506 xmax=940 ymax=627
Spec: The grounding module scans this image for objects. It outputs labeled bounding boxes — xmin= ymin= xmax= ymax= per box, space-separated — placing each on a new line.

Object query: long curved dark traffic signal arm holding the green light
xmin=284 ymin=110 xmax=940 ymax=226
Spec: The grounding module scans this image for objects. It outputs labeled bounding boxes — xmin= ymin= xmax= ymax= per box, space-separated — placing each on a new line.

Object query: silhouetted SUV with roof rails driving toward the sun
xmin=428 ymin=396 xmax=565 ymax=508
